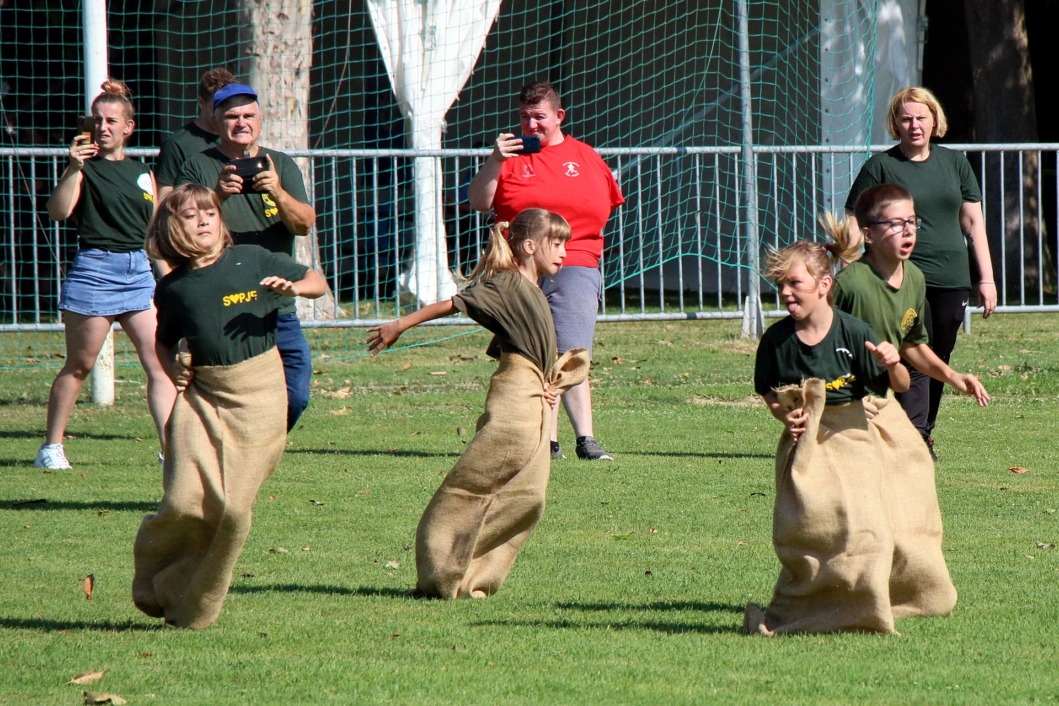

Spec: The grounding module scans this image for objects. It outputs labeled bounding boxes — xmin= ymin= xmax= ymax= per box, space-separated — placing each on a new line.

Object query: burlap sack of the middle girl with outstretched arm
xmin=415 ymin=348 xmax=589 ymax=598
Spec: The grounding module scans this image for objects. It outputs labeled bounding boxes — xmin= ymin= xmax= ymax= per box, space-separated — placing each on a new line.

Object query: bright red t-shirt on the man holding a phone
xmin=492 ymin=137 xmax=625 ymax=267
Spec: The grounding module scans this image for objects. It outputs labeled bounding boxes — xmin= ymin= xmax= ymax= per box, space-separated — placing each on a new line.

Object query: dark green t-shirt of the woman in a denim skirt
xmin=73 ymin=157 xmax=155 ymax=253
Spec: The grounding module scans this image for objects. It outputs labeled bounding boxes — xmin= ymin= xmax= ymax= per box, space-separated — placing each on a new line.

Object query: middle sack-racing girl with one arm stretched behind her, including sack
xmin=367 ymin=209 xmax=589 ymax=598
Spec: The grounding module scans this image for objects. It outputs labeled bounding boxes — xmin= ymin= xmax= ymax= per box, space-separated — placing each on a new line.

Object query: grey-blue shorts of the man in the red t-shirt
xmin=540 ymin=265 xmax=603 ymax=355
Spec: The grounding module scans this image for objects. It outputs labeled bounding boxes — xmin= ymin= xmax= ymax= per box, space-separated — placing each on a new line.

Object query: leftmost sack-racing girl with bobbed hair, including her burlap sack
xmin=132 ymin=184 xmax=327 ymax=628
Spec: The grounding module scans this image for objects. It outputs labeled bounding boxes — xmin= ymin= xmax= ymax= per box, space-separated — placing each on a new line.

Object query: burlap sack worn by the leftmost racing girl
xmin=132 ymin=348 xmax=287 ymax=628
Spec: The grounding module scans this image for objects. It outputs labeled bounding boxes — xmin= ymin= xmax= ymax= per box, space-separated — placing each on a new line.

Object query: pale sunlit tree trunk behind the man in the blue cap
xmin=241 ymin=0 xmax=342 ymax=319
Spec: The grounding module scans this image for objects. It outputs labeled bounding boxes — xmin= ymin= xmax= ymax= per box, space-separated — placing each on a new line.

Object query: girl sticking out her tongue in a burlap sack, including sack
xmin=744 ymin=237 xmax=914 ymax=635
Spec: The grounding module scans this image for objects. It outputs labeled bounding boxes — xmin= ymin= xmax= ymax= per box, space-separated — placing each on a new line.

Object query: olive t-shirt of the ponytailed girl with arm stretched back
xmin=452 ymin=271 xmax=557 ymax=377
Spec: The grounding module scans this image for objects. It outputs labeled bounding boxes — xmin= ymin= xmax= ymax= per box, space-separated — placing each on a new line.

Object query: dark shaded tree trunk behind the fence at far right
xmin=965 ymin=0 xmax=1055 ymax=303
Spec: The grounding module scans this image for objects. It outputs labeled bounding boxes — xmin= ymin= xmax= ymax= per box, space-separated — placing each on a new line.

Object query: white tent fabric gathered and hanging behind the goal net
xmin=367 ymin=0 xmax=501 ymax=304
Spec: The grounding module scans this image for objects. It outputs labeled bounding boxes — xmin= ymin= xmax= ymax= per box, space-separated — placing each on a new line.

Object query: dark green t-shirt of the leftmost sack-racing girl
xmin=155 ymin=246 xmax=308 ymax=365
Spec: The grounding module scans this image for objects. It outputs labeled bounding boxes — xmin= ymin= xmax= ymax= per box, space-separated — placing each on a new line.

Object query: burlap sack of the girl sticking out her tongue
xmin=744 ymin=380 xmax=893 ymax=634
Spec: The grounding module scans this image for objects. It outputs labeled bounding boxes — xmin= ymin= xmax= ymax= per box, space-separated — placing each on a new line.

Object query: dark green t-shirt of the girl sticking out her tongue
xmin=754 ymin=309 xmax=890 ymax=404
